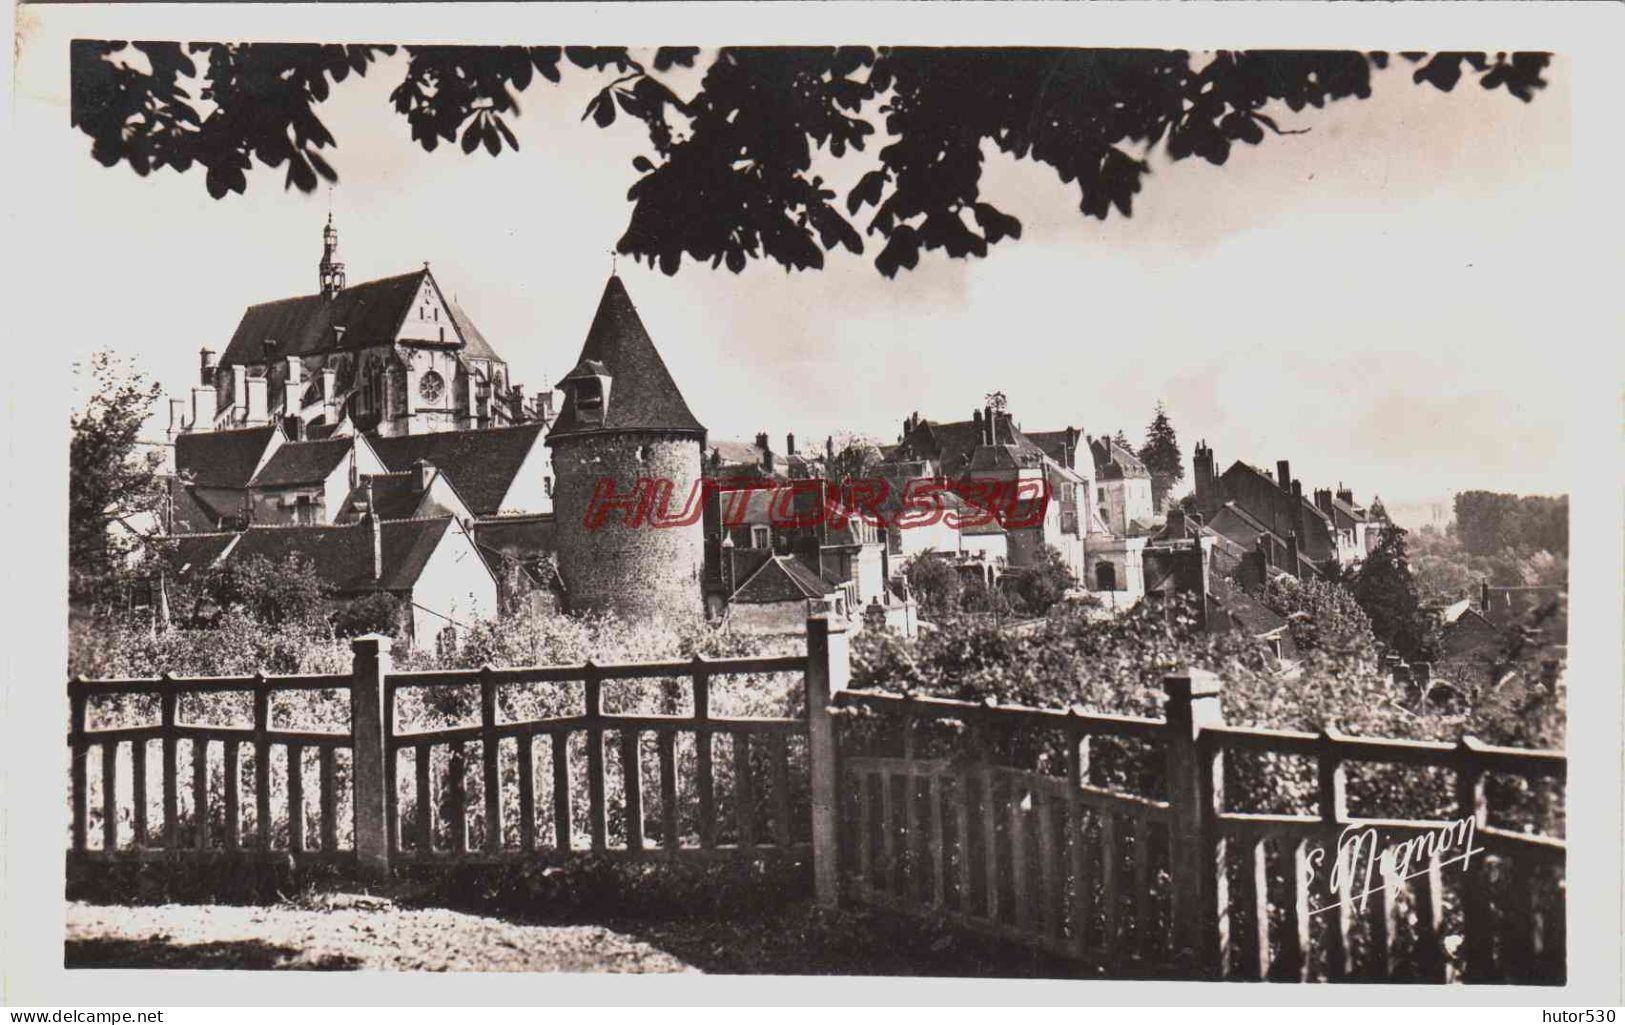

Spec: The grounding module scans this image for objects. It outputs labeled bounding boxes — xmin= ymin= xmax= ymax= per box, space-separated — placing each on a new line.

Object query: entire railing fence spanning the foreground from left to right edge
xmin=68 ymin=617 xmax=1567 ymax=983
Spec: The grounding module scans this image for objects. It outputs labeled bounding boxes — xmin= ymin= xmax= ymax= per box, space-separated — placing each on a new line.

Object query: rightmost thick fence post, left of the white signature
xmin=1162 ymin=669 xmax=1224 ymax=975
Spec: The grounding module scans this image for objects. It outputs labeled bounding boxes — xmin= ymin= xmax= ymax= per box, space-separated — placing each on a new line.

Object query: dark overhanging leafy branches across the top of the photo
xmin=70 ymin=39 xmax=1550 ymax=276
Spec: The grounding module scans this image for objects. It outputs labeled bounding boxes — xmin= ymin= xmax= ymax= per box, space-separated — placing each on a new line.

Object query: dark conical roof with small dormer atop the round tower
xmin=548 ymin=276 xmax=705 ymax=443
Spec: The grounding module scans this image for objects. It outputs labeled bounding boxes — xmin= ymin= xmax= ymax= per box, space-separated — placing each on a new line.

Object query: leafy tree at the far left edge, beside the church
xmin=68 ymin=352 xmax=159 ymax=603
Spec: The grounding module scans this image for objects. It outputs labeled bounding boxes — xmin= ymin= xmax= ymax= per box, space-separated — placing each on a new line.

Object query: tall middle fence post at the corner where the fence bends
xmin=806 ymin=614 xmax=852 ymax=906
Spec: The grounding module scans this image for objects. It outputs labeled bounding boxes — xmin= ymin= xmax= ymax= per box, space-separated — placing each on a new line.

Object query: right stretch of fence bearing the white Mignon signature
xmin=835 ymin=673 xmax=1567 ymax=984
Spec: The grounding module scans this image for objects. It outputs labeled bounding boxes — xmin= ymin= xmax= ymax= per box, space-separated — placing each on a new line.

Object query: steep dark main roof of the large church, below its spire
xmin=219 ymin=266 xmax=499 ymax=367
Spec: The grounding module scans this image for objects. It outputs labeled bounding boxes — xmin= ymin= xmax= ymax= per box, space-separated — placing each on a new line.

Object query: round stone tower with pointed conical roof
xmin=548 ymin=276 xmax=705 ymax=622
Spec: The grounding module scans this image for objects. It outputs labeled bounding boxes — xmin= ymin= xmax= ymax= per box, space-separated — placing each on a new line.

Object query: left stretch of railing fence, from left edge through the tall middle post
xmin=68 ymin=619 xmax=847 ymax=887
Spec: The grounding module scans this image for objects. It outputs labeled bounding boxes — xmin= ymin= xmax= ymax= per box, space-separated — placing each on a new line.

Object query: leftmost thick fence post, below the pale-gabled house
xmin=349 ymin=634 xmax=392 ymax=877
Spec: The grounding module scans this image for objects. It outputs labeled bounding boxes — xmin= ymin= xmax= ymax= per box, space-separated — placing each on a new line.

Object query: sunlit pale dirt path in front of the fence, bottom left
xmin=65 ymin=897 xmax=697 ymax=971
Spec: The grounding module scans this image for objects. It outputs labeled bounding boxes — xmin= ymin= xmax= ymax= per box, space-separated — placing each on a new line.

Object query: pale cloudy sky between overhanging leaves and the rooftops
xmin=20 ymin=44 xmax=1576 ymax=516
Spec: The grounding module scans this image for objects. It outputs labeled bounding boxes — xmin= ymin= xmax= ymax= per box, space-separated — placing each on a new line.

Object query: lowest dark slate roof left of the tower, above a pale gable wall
xmin=229 ymin=517 xmax=452 ymax=591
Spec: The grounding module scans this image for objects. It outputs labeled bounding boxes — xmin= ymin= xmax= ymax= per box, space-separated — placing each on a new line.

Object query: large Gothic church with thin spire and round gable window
xmin=169 ymin=216 xmax=553 ymax=437
